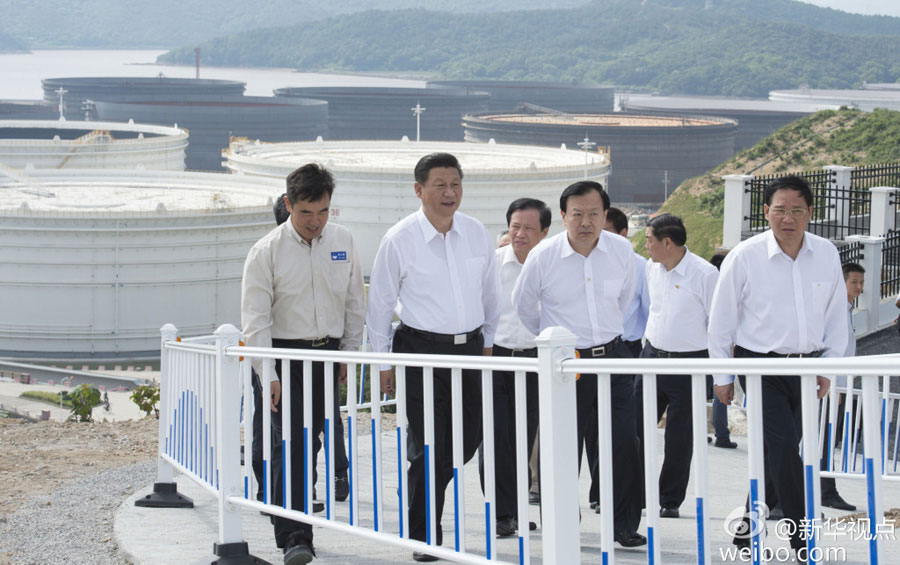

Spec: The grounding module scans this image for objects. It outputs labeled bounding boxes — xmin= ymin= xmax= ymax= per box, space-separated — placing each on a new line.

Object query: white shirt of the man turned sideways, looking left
xmin=646 ymin=247 xmax=719 ymax=352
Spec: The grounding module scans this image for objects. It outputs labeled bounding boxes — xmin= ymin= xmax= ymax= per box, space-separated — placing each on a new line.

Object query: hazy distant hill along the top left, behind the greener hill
xmin=0 ymin=0 xmax=589 ymax=49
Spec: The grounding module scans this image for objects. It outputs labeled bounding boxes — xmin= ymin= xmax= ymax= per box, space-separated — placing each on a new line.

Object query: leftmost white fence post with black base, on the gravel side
xmin=134 ymin=324 xmax=194 ymax=508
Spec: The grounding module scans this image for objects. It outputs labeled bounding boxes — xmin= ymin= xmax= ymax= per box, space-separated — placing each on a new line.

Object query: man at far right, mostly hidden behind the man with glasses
xmin=820 ymin=263 xmax=866 ymax=512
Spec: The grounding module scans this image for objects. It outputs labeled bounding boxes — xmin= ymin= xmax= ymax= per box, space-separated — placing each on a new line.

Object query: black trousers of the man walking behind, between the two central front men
xmin=478 ymin=345 xmax=540 ymax=520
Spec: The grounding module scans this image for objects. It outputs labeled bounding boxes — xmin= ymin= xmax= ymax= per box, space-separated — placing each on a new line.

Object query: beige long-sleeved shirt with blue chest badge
xmin=241 ymin=221 xmax=366 ymax=375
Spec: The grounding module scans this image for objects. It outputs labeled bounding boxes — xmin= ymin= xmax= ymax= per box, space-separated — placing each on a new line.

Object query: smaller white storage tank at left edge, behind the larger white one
xmin=0 ymin=120 xmax=188 ymax=171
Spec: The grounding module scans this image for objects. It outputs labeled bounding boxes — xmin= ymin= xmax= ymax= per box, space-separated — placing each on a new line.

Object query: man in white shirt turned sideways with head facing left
xmin=634 ymin=214 xmax=719 ymax=518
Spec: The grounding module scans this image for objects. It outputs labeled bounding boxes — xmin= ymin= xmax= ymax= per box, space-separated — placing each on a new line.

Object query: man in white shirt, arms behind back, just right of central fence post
xmin=513 ymin=181 xmax=647 ymax=547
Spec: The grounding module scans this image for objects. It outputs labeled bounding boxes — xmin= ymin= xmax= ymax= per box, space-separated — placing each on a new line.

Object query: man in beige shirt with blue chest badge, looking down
xmin=241 ymin=164 xmax=365 ymax=565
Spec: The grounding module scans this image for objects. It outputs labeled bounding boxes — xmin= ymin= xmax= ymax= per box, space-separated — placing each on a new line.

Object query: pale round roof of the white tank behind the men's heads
xmin=228 ymin=141 xmax=606 ymax=174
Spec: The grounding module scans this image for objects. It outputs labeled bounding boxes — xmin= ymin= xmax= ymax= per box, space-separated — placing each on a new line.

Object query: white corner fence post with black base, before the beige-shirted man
xmin=211 ymin=324 xmax=262 ymax=565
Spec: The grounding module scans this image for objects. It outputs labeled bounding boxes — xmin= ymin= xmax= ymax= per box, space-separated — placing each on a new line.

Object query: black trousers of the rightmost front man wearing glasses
xmin=734 ymin=347 xmax=806 ymax=549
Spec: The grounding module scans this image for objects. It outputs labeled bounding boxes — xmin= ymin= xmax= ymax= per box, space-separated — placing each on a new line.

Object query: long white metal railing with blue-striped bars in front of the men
xmin=149 ymin=325 xmax=900 ymax=564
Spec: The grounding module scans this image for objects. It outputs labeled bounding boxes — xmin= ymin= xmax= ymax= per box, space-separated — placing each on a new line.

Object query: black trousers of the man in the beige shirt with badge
xmin=272 ymin=339 xmax=340 ymax=547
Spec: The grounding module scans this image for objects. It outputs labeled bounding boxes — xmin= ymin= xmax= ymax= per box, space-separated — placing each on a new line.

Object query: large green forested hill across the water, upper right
xmin=160 ymin=0 xmax=900 ymax=97
